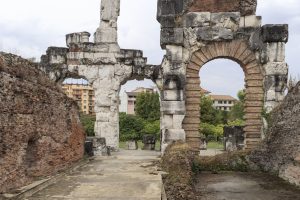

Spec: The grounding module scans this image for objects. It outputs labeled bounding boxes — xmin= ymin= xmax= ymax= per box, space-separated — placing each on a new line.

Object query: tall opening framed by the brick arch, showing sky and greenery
xmin=199 ymin=59 xmax=245 ymax=155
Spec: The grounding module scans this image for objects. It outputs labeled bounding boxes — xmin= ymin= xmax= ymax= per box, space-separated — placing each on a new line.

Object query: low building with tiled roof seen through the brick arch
xmin=209 ymin=95 xmax=237 ymax=111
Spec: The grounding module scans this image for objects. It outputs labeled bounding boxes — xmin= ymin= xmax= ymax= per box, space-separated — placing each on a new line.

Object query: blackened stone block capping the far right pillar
xmin=261 ymin=24 xmax=289 ymax=43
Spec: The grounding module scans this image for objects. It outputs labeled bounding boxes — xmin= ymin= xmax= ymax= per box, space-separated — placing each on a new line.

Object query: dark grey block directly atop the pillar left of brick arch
xmin=160 ymin=28 xmax=183 ymax=49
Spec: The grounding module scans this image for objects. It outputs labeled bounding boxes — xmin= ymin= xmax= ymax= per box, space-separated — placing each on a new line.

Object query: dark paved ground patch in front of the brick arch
xmin=196 ymin=172 xmax=300 ymax=200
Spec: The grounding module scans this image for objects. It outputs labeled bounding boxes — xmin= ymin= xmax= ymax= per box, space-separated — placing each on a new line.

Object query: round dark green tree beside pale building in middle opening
xmin=135 ymin=92 xmax=160 ymax=121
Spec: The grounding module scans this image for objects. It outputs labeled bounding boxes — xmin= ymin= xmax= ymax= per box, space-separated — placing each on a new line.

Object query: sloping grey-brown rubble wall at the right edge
xmin=251 ymin=82 xmax=300 ymax=185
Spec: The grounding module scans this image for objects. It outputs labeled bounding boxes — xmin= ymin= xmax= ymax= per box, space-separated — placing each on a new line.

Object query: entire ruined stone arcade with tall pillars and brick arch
xmin=41 ymin=0 xmax=288 ymax=151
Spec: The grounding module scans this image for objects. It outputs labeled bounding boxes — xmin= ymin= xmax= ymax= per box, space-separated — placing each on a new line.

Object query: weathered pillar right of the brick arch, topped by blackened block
xmin=262 ymin=25 xmax=288 ymax=112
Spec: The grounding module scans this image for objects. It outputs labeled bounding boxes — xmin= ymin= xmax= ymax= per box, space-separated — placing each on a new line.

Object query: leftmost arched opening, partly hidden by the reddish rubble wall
xmin=62 ymin=78 xmax=96 ymax=136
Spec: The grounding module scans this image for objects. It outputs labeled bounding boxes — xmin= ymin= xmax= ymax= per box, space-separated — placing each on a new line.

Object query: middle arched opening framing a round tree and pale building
xmin=119 ymin=79 xmax=161 ymax=151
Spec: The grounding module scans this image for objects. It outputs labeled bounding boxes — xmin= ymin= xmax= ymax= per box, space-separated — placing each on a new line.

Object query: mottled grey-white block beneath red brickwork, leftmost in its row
xmin=184 ymin=12 xmax=211 ymax=28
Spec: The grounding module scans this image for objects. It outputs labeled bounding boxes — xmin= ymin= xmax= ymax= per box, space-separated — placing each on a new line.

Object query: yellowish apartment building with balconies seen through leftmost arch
xmin=62 ymin=84 xmax=95 ymax=115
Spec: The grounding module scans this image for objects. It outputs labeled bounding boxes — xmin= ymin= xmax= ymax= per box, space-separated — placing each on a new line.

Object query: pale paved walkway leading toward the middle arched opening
xmin=27 ymin=150 xmax=162 ymax=200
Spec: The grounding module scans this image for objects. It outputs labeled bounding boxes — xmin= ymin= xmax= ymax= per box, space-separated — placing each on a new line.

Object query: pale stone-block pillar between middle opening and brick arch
xmin=161 ymin=45 xmax=186 ymax=152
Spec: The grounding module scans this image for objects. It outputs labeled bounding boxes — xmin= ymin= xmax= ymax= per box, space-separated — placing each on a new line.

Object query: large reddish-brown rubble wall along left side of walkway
xmin=0 ymin=53 xmax=85 ymax=193
